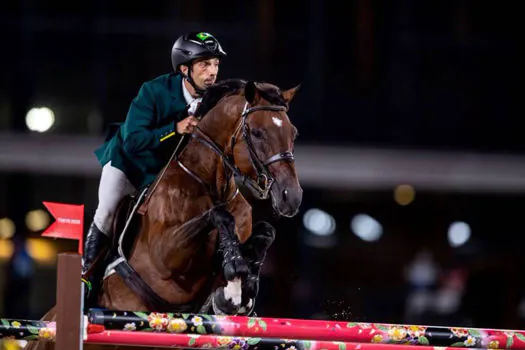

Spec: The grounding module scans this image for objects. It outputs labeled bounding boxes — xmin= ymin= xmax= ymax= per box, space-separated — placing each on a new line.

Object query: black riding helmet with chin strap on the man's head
xmin=171 ymin=32 xmax=226 ymax=95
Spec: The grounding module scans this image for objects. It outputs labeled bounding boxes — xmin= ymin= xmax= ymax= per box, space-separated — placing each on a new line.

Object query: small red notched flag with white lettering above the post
xmin=42 ymin=202 xmax=84 ymax=255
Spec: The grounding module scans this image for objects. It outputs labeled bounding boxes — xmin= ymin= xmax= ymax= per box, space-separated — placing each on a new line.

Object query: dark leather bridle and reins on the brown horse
xmin=178 ymin=102 xmax=295 ymax=199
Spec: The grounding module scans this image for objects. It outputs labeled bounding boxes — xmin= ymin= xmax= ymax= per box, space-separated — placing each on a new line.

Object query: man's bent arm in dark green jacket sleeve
xmin=123 ymin=85 xmax=179 ymax=153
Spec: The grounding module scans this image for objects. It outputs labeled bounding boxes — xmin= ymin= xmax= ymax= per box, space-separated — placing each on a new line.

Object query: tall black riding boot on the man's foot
xmin=82 ymin=222 xmax=110 ymax=310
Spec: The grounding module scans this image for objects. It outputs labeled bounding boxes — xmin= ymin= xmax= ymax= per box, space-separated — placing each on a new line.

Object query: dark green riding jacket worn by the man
xmin=95 ymin=73 xmax=187 ymax=189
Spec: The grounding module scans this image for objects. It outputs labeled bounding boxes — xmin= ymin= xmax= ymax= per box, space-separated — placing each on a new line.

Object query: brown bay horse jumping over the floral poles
xmin=27 ymin=79 xmax=302 ymax=350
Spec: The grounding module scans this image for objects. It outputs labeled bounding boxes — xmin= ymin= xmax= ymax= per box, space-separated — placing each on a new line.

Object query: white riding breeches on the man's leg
xmin=93 ymin=162 xmax=135 ymax=237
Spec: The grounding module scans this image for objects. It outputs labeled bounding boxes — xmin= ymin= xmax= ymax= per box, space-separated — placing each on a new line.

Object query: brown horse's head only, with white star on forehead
xmin=232 ymin=81 xmax=303 ymax=217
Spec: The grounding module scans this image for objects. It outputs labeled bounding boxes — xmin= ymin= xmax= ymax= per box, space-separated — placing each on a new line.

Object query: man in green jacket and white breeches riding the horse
xmin=82 ymin=32 xmax=226 ymax=304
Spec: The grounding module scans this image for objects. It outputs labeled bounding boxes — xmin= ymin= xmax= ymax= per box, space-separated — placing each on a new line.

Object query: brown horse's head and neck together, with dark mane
xmin=194 ymin=79 xmax=303 ymax=217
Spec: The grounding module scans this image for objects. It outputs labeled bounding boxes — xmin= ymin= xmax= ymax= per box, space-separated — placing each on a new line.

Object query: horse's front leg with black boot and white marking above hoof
xmin=212 ymin=208 xmax=250 ymax=314
